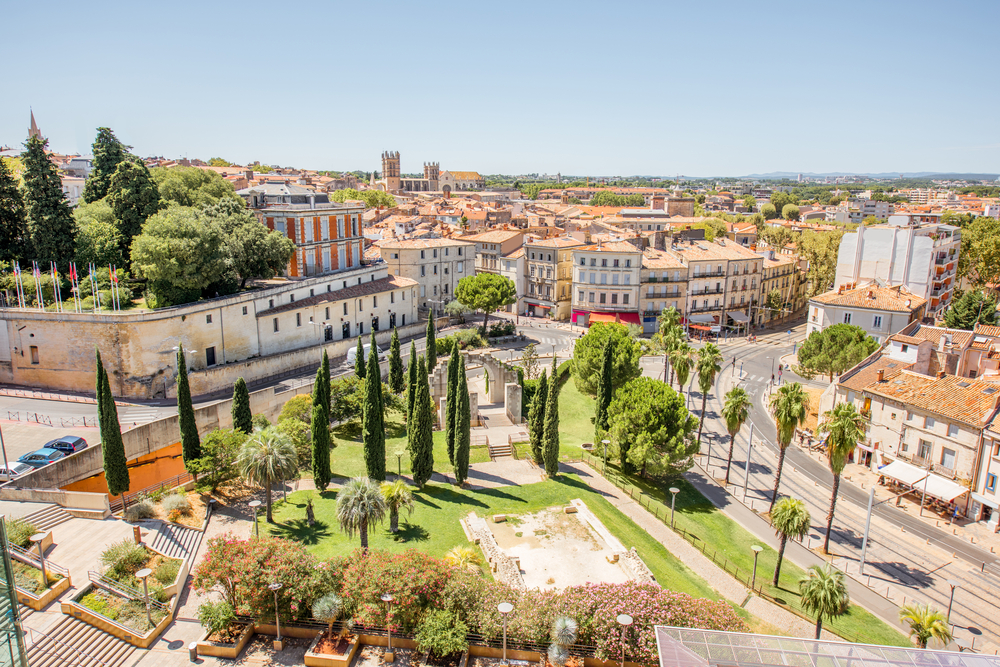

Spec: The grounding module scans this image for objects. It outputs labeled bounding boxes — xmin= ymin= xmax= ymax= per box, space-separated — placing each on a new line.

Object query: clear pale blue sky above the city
xmin=0 ymin=0 xmax=1000 ymax=176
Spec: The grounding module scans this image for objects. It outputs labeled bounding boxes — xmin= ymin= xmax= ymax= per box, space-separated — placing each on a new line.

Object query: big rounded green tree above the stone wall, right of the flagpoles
xmin=132 ymin=206 xmax=228 ymax=308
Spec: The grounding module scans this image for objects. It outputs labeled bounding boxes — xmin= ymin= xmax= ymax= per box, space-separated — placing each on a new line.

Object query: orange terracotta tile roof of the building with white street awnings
xmin=865 ymin=370 xmax=1000 ymax=427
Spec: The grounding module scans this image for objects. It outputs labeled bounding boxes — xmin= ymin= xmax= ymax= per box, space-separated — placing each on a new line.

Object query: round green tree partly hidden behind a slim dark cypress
xmin=573 ymin=322 xmax=642 ymax=396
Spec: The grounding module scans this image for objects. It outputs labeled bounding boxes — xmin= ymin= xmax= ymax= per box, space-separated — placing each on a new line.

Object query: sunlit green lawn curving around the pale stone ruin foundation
xmin=260 ymin=475 xmax=719 ymax=599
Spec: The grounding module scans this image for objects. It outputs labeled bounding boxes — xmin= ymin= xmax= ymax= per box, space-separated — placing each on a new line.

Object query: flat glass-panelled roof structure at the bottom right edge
xmin=656 ymin=626 xmax=1000 ymax=667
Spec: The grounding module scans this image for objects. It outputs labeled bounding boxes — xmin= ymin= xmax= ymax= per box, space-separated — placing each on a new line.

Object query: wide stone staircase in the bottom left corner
xmin=28 ymin=616 xmax=135 ymax=667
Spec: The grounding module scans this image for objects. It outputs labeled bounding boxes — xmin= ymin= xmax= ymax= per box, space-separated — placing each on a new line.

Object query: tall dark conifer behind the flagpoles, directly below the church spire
xmin=22 ymin=137 xmax=76 ymax=270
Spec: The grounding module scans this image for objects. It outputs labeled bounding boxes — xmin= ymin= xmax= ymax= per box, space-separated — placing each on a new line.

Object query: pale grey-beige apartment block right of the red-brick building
xmin=376 ymin=239 xmax=476 ymax=311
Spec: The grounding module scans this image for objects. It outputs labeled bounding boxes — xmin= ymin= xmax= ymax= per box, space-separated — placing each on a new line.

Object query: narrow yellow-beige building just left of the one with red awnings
xmin=524 ymin=236 xmax=586 ymax=320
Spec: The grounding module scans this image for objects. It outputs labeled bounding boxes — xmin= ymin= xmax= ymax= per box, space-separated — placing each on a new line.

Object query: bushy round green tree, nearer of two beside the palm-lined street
xmin=608 ymin=377 xmax=698 ymax=476
